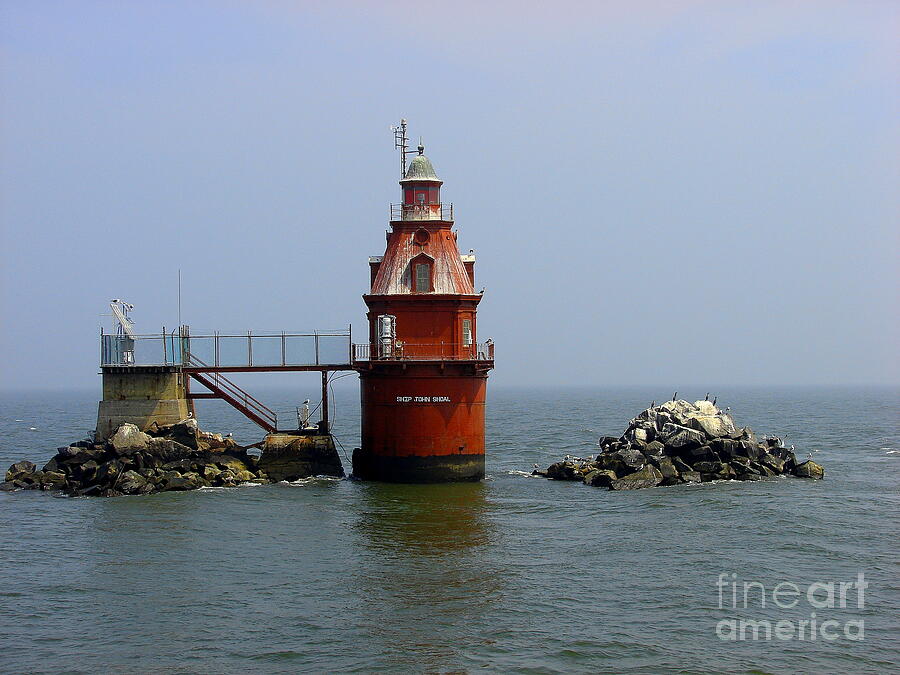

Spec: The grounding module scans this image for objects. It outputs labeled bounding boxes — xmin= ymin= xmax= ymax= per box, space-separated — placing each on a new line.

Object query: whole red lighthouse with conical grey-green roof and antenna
xmin=353 ymin=121 xmax=494 ymax=483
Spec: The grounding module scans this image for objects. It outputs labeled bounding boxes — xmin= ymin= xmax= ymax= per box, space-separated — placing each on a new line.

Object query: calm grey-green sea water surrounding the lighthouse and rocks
xmin=0 ymin=388 xmax=900 ymax=673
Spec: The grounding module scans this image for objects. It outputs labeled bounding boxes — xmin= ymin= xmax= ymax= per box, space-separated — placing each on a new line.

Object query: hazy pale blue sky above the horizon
xmin=0 ymin=0 xmax=900 ymax=390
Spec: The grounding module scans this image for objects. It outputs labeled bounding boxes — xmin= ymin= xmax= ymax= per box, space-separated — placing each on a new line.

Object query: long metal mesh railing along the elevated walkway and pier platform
xmin=100 ymin=327 xmax=352 ymax=368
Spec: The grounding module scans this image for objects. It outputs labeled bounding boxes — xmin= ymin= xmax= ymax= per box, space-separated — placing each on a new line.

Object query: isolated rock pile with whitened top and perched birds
xmin=534 ymin=400 xmax=825 ymax=490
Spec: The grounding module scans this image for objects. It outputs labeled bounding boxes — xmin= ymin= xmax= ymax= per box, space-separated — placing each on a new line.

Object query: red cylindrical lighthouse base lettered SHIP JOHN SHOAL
xmin=353 ymin=362 xmax=487 ymax=483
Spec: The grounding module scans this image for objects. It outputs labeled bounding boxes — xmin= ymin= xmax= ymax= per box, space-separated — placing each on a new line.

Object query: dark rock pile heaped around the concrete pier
xmin=0 ymin=419 xmax=268 ymax=497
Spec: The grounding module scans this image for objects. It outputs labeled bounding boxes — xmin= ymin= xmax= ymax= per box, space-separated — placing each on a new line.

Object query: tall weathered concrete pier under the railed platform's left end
xmin=95 ymin=366 xmax=190 ymax=440
